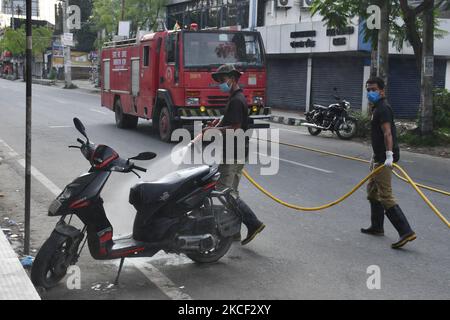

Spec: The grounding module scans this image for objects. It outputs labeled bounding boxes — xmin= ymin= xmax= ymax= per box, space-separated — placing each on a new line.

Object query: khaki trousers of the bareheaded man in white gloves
xmin=367 ymin=163 xmax=397 ymax=210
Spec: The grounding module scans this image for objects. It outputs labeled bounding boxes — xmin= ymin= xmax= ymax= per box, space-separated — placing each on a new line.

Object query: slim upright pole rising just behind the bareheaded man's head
xmin=377 ymin=0 xmax=390 ymax=93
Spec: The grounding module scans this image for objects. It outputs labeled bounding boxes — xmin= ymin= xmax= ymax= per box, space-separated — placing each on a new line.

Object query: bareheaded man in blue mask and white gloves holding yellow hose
xmin=361 ymin=78 xmax=416 ymax=249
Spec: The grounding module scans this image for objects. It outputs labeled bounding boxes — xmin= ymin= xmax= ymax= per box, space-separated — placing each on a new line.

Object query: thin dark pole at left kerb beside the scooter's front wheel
xmin=23 ymin=0 xmax=33 ymax=255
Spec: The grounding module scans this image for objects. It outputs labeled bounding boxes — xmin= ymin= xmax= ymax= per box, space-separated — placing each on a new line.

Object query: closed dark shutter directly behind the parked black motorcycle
xmin=311 ymin=56 xmax=364 ymax=109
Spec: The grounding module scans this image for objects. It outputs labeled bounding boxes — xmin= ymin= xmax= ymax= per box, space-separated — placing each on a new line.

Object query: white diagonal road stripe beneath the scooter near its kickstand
xmin=127 ymin=258 xmax=193 ymax=300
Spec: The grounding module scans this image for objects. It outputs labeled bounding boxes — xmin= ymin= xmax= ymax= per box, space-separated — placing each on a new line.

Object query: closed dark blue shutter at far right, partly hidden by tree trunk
xmin=388 ymin=57 xmax=447 ymax=119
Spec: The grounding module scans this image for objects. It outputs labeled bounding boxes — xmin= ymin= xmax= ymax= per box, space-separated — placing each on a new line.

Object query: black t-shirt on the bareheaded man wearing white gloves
xmin=371 ymin=99 xmax=400 ymax=163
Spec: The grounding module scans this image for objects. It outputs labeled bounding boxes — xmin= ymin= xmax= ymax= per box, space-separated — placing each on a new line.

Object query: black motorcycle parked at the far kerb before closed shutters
xmin=302 ymin=88 xmax=358 ymax=140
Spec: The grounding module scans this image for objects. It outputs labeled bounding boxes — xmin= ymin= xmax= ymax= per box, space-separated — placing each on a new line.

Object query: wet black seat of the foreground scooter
xmin=129 ymin=166 xmax=210 ymax=210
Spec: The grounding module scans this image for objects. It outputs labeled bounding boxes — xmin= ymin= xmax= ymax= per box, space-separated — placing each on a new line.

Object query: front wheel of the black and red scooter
xmin=31 ymin=232 xmax=76 ymax=289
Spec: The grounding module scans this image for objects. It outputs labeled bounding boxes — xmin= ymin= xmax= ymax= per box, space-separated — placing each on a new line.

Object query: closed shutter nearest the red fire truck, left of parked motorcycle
xmin=267 ymin=58 xmax=308 ymax=111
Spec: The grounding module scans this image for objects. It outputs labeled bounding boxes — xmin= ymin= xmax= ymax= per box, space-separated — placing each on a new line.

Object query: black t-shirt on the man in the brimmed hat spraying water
xmin=222 ymin=89 xmax=249 ymax=160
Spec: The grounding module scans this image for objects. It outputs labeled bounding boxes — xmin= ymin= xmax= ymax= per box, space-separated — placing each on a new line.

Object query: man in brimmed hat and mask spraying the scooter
xmin=205 ymin=65 xmax=265 ymax=245
